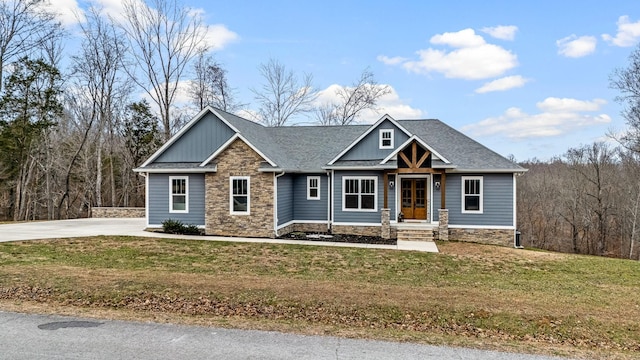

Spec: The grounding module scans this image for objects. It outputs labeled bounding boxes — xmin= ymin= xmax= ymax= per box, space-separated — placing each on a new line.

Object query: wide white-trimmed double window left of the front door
xmin=342 ymin=176 xmax=378 ymax=211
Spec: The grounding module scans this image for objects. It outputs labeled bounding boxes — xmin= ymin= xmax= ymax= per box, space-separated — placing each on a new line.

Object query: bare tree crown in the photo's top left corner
xmin=0 ymin=0 xmax=61 ymax=90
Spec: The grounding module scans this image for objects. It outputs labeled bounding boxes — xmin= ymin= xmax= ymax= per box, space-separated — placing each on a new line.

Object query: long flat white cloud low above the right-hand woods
xmin=462 ymin=98 xmax=611 ymax=139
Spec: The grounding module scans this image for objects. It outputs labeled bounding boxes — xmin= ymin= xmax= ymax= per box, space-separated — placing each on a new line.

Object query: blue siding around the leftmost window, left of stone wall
xmin=147 ymin=174 xmax=204 ymax=225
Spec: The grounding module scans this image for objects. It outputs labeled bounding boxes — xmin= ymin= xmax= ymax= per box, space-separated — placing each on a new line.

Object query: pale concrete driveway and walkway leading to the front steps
xmin=0 ymin=218 xmax=438 ymax=252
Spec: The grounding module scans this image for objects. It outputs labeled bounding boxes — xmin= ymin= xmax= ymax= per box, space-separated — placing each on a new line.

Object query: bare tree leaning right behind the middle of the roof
xmin=316 ymin=69 xmax=391 ymax=125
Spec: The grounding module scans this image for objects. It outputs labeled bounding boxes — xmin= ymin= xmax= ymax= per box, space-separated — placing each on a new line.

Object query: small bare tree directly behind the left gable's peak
xmin=189 ymin=52 xmax=242 ymax=112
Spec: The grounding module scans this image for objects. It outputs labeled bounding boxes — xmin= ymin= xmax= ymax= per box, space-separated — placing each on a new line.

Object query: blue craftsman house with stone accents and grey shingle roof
xmin=135 ymin=108 xmax=525 ymax=245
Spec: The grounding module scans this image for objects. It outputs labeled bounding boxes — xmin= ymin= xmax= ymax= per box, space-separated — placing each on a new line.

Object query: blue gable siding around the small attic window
xmin=340 ymin=120 xmax=409 ymax=160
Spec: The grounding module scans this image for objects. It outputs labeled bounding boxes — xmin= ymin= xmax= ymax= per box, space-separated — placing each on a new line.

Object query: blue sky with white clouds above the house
xmin=52 ymin=0 xmax=640 ymax=160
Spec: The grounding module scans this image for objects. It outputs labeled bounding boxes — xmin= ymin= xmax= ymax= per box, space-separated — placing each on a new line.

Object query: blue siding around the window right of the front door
xmin=446 ymin=174 xmax=513 ymax=226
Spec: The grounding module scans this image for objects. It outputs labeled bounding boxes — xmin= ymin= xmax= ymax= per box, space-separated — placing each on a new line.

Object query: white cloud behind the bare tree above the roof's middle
xmin=315 ymin=84 xmax=424 ymax=124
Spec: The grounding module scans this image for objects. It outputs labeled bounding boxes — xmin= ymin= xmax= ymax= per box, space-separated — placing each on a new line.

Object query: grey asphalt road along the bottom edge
xmin=0 ymin=312 xmax=559 ymax=360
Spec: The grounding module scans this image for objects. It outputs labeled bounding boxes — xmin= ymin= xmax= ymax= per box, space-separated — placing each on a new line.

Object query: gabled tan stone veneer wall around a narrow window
xmin=204 ymin=139 xmax=275 ymax=237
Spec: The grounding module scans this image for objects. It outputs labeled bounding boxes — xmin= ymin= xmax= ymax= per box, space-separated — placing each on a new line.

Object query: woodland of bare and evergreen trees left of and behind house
xmin=0 ymin=0 xmax=390 ymax=220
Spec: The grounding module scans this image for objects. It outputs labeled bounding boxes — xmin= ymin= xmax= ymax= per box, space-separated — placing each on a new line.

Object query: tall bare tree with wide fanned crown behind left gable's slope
xmin=121 ymin=0 xmax=206 ymax=139
